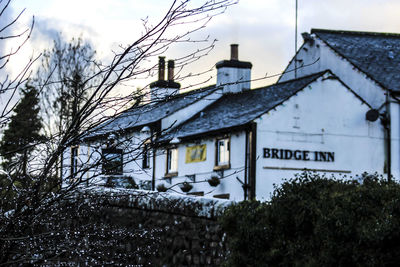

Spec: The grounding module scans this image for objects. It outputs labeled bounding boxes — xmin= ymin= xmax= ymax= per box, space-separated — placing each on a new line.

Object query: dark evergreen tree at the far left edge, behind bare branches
xmin=0 ymin=84 xmax=42 ymax=176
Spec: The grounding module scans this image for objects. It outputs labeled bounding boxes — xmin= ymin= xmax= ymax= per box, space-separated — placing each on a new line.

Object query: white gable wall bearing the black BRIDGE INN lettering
xmin=256 ymin=74 xmax=385 ymax=199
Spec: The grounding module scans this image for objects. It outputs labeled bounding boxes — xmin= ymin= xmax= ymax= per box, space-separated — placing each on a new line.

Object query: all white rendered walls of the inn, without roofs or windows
xmin=64 ymin=39 xmax=400 ymax=201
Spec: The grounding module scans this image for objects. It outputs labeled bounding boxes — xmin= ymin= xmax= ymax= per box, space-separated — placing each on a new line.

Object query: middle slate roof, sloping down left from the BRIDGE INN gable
xmin=158 ymin=71 xmax=328 ymax=142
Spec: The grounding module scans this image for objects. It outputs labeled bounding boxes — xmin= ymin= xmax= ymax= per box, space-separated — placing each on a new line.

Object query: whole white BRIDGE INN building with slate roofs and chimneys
xmin=65 ymin=30 xmax=400 ymax=200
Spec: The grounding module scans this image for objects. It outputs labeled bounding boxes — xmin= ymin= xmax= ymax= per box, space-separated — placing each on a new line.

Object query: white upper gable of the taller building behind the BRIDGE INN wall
xmin=279 ymin=34 xmax=400 ymax=178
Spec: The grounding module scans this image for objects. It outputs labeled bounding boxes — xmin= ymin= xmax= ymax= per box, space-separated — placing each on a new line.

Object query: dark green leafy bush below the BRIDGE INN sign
xmin=221 ymin=173 xmax=400 ymax=266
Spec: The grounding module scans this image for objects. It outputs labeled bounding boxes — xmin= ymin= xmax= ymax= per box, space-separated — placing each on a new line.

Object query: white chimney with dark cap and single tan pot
xmin=216 ymin=44 xmax=253 ymax=93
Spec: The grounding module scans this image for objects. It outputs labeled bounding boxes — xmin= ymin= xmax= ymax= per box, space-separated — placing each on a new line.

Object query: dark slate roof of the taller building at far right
xmin=311 ymin=29 xmax=400 ymax=92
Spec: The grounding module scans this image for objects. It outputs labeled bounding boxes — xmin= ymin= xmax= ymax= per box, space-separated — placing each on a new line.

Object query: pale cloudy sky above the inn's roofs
xmin=5 ymin=0 xmax=400 ymax=90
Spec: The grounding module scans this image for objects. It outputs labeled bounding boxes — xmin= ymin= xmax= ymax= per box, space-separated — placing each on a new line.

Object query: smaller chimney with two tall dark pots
xmin=150 ymin=57 xmax=181 ymax=100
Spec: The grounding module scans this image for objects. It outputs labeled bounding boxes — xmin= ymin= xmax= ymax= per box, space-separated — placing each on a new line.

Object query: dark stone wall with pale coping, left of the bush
xmin=72 ymin=190 xmax=231 ymax=266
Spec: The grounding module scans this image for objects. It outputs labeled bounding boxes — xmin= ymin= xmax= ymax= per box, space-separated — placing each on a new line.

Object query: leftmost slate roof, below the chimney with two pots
xmin=85 ymin=85 xmax=217 ymax=138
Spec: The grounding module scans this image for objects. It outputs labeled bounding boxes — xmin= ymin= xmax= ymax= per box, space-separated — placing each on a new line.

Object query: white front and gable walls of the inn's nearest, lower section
xmin=152 ymin=73 xmax=385 ymax=200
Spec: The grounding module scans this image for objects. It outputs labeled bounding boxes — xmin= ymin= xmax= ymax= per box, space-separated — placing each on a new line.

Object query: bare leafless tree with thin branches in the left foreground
xmin=0 ymin=0 xmax=236 ymax=265
